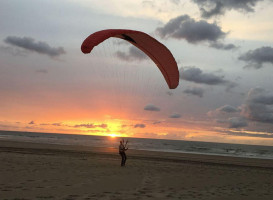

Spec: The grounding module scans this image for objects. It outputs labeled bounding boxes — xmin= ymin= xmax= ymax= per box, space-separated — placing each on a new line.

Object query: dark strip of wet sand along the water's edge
xmin=0 ymin=140 xmax=273 ymax=169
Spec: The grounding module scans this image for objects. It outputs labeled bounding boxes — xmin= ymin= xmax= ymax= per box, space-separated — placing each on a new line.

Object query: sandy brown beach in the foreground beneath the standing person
xmin=0 ymin=140 xmax=273 ymax=200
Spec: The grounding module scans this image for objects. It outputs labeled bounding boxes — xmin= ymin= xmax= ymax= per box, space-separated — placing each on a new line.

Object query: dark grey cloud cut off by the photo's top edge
xmin=192 ymin=0 xmax=263 ymax=18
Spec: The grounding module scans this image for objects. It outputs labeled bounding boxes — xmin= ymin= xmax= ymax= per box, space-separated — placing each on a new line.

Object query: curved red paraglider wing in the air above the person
xmin=81 ymin=29 xmax=179 ymax=89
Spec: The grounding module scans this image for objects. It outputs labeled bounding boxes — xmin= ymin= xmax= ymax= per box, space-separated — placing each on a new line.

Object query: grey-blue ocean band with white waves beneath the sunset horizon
xmin=0 ymin=131 xmax=273 ymax=159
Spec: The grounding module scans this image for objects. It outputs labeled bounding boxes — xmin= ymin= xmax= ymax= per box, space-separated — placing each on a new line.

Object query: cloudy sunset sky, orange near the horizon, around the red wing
xmin=0 ymin=0 xmax=273 ymax=146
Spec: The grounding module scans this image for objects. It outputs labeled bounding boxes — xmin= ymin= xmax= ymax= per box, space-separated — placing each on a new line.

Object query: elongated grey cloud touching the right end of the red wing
xmin=180 ymin=67 xmax=237 ymax=91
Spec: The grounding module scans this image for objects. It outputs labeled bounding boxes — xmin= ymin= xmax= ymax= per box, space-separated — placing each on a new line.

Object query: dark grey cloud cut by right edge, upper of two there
xmin=238 ymin=46 xmax=273 ymax=69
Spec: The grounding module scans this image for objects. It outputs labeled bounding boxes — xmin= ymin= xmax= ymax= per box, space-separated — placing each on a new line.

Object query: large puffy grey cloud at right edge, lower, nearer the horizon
xmin=241 ymin=88 xmax=273 ymax=123
